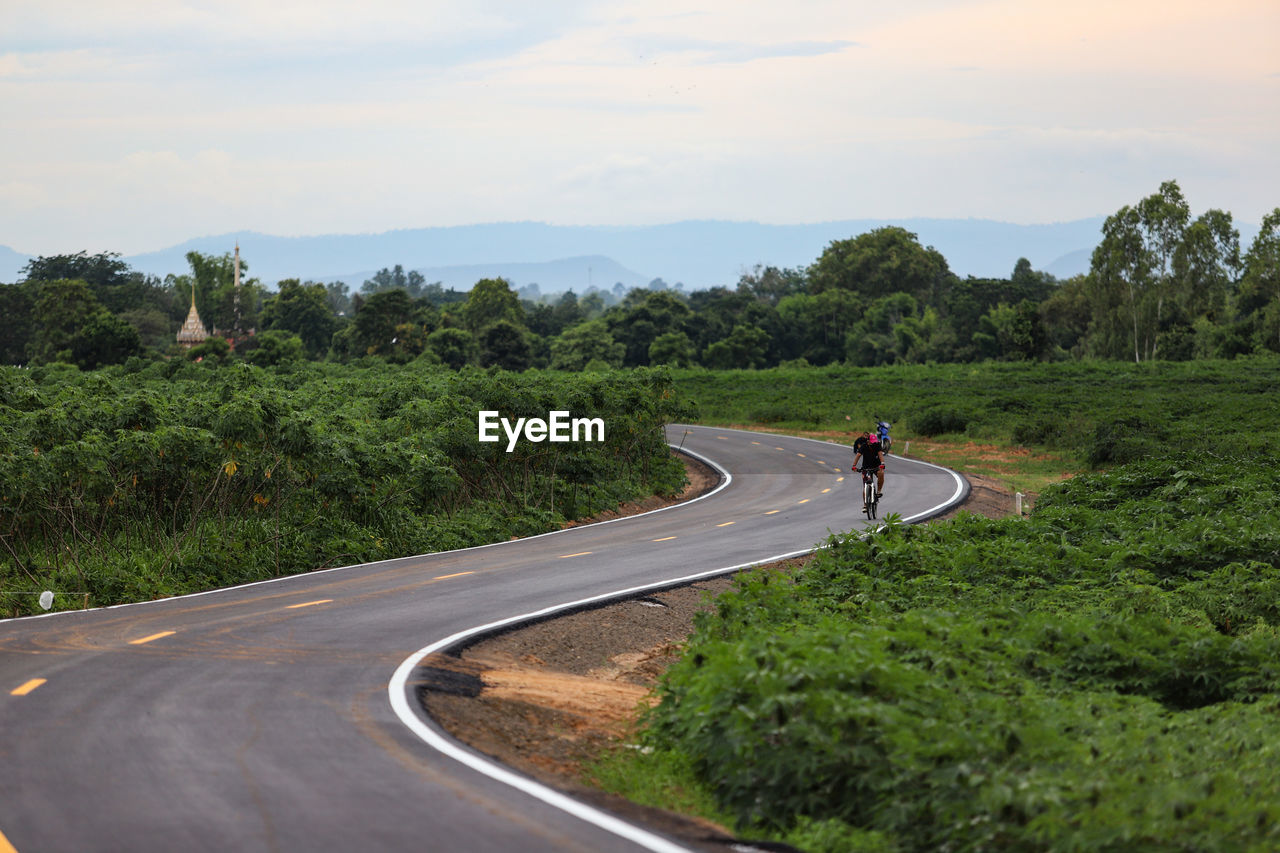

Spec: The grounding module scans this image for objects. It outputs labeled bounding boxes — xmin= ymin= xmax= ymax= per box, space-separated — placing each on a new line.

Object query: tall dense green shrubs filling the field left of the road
xmin=0 ymin=359 xmax=684 ymax=615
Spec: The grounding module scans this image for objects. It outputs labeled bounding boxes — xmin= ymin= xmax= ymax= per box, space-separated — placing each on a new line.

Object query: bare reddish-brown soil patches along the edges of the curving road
xmin=422 ymin=448 xmax=1014 ymax=850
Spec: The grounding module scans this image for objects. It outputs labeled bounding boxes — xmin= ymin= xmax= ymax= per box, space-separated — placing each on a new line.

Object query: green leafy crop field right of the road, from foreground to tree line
xmin=609 ymin=360 xmax=1280 ymax=852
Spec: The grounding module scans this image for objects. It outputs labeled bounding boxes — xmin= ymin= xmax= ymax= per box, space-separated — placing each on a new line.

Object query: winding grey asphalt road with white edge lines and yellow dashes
xmin=0 ymin=427 xmax=966 ymax=853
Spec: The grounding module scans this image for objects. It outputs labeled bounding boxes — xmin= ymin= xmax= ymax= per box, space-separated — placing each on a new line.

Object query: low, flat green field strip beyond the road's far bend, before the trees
xmin=675 ymin=356 xmax=1280 ymax=466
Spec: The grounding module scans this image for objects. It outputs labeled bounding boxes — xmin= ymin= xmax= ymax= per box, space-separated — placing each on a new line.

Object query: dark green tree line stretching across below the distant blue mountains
xmin=0 ymin=181 xmax=1280 ymax=370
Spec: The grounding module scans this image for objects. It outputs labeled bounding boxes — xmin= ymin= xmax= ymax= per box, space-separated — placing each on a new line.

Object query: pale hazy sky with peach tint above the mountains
xmin=0 ymin=0 xmax=1280 ymax=255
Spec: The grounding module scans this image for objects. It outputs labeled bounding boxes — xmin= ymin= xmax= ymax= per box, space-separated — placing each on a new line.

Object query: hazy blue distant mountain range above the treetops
xmin=0 ymin=216 xmax=1126 ymax=293
